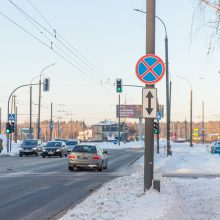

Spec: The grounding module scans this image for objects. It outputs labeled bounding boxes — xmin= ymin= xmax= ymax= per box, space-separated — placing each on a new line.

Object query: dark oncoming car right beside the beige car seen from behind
xmin=41 ymin=141 xmax=67 ymax=158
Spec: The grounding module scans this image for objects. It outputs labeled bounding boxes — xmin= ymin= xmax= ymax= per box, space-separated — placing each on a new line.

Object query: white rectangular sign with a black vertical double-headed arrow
xmin=142 ymin=88 xmax=157 ymax=118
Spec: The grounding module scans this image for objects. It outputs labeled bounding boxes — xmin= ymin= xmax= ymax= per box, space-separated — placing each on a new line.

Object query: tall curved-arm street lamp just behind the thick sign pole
xmin=134 ymin=9 xmax=172 ymax=156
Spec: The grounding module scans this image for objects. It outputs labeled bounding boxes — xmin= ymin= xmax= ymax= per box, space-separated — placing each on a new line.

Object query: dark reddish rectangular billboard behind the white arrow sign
xmin=116 ymin=105 xmax=142 ymax=118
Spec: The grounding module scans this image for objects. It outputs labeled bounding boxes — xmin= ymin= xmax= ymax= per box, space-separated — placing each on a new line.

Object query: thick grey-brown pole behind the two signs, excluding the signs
xmin=144 ymin=0 xmax=156 ymax=191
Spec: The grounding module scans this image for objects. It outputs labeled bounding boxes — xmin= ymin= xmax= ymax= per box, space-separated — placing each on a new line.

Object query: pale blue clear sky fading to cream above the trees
xmin=0 ymin=0 xmax=220 ymax=124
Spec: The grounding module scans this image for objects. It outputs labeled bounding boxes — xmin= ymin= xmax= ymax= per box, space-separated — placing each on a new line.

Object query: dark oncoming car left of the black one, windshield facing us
xmin=19 ymin=139 xmax=42 ymax=157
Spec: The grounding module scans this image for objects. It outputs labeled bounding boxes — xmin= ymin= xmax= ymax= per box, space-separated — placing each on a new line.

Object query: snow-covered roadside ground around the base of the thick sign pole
xmin=60 ymin=143 xmax=220 ymax=220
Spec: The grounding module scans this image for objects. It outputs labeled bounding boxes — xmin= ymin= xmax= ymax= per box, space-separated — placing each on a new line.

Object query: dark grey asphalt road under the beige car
xmin=0 ymin=149 xmax=143 ymax=220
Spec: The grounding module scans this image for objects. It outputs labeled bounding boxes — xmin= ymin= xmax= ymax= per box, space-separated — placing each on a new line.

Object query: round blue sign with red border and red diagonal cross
xmin=136 ymin=54 xmax=165 ymax=85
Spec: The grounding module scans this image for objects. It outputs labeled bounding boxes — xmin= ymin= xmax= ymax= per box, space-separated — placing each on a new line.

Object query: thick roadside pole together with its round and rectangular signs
xmin=136 ymin=52 xmax=165 ymax=191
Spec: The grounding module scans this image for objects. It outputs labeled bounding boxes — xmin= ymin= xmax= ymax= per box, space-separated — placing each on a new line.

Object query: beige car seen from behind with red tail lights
xmin=68 ymin=145 xmax=108 ymax=172
